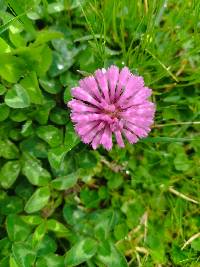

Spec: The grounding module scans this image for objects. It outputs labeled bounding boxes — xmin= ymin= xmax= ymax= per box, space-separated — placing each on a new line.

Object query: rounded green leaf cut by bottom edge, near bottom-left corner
xmin=12 ymin=242 xmax=36 ymax=267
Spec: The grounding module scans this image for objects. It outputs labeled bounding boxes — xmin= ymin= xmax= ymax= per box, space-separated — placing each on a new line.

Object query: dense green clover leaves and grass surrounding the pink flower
xmin=0 ymin=0 xmax=200 ymax=267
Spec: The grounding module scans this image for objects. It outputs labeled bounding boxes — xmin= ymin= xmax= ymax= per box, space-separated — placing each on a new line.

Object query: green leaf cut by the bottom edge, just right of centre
xmin=97 ymin=240 xmax=128 ymax=267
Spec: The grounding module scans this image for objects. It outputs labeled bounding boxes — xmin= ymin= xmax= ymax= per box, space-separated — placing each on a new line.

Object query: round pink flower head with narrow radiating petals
xmin=68 ymin=66 xmax=155 ymax=150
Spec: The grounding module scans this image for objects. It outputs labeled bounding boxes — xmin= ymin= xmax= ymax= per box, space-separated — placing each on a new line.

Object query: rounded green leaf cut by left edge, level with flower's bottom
xmin=0 ymin=140 xmax=19 ymax=159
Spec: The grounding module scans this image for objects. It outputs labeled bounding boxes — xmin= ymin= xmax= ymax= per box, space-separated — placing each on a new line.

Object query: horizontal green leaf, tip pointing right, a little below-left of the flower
xmin=51 ymin=173 xmax=78 ymax=190
